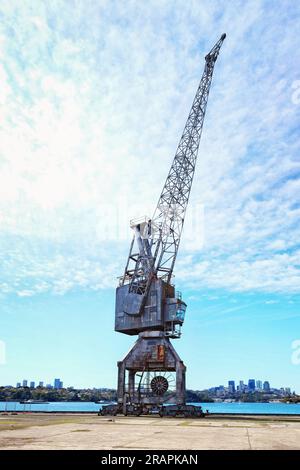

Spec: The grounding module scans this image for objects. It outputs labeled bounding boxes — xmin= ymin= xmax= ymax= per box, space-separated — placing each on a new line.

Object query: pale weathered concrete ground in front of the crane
xmin=0 ymin=414 xmax=300 ymax=450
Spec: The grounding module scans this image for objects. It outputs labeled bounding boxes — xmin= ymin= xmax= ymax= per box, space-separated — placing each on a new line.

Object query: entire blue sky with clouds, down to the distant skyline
xmin=0 ymin=0 xmax=300 ymax=393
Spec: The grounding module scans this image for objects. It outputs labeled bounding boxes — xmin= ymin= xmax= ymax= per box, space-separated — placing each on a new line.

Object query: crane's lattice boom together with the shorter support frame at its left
xmin=120 ymin=34 xmax=226 ymax=313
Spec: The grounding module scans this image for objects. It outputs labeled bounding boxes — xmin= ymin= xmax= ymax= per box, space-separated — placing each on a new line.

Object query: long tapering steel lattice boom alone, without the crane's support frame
xmin=152 ymin=35 xmax=225 ymax=282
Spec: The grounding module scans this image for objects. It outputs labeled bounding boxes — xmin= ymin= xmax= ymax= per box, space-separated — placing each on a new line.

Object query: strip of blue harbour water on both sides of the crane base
xmin=0 ymin=401 xmax=300 ymax=415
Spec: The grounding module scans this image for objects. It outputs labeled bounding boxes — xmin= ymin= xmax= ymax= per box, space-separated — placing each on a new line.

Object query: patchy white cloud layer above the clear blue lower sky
xmin=0 ymin=0 xmax=300 ymax=295
